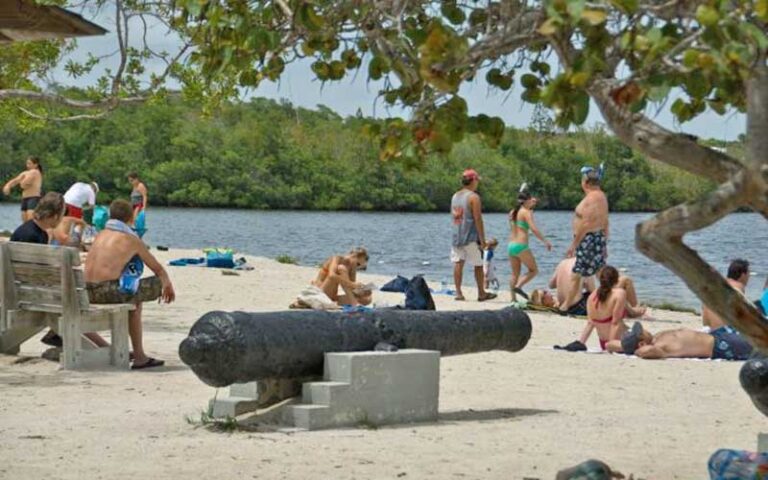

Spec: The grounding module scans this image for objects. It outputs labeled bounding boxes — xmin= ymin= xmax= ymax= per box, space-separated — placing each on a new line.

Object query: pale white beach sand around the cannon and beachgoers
xmin=0 ymin=250 xmax=768 ymax=479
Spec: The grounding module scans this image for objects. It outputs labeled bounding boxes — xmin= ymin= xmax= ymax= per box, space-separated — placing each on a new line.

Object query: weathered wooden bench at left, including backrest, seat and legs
xmin=0 ymin=242 xmax=134 ymax=369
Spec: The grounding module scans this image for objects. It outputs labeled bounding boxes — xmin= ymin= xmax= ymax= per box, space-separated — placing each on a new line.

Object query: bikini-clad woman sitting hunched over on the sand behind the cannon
xmin=312 ymin=247 xmax=373 ymax=305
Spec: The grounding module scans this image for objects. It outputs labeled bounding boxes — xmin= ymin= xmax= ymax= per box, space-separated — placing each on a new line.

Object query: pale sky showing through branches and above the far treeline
xmin=54 ymin=7 xmax=746 ymax=140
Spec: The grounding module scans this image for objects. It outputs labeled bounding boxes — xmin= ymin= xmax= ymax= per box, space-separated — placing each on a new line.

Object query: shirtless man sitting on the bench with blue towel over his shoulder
xmin=85 ymin=200 xmax=176 ymax=370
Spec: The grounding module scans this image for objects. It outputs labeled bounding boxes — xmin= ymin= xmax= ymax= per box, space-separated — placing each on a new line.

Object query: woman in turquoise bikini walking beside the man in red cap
xmin=507 ymin=184 xmax=552 ymax=302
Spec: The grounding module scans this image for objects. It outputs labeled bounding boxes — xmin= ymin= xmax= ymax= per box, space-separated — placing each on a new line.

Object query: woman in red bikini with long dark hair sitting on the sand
xmin=579 ymin=265 xmax=646 ymax=350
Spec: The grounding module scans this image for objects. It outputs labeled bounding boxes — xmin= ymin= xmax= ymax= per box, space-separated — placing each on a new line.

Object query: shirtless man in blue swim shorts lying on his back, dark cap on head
xmin=608 ymin=322 xmax=752 ymax=360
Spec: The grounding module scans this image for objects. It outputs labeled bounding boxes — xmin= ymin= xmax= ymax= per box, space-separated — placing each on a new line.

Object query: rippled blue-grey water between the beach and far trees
xmin=0 ymin=204 xmax=768 ymax=307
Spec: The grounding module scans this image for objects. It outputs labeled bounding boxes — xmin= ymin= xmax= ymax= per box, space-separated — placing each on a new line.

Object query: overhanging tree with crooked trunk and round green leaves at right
xmin=170 ymin=0 xmax=768 ymax=352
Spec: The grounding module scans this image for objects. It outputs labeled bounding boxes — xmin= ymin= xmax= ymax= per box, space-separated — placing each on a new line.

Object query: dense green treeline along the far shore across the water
xmin=0 ymin=95 xmax=709 ymax=211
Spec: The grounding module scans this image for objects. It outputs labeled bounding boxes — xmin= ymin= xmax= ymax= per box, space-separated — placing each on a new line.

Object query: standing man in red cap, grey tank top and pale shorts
xmin=451 ymin=168 xmax=496 ymax=302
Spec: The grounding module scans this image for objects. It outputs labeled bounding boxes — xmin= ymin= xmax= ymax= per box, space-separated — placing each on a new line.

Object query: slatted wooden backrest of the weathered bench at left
xmin=0 ymin=242 xmax=90 ymax=316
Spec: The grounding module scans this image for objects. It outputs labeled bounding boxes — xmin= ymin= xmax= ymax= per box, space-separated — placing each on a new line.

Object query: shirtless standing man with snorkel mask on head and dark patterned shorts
xmin=560 ymin=164 xmax=608 ymax=314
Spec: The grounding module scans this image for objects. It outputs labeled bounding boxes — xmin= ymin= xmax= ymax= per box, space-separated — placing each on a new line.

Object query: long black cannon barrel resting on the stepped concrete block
xmin=179 ymin=307 xmax=531 ymax=387
